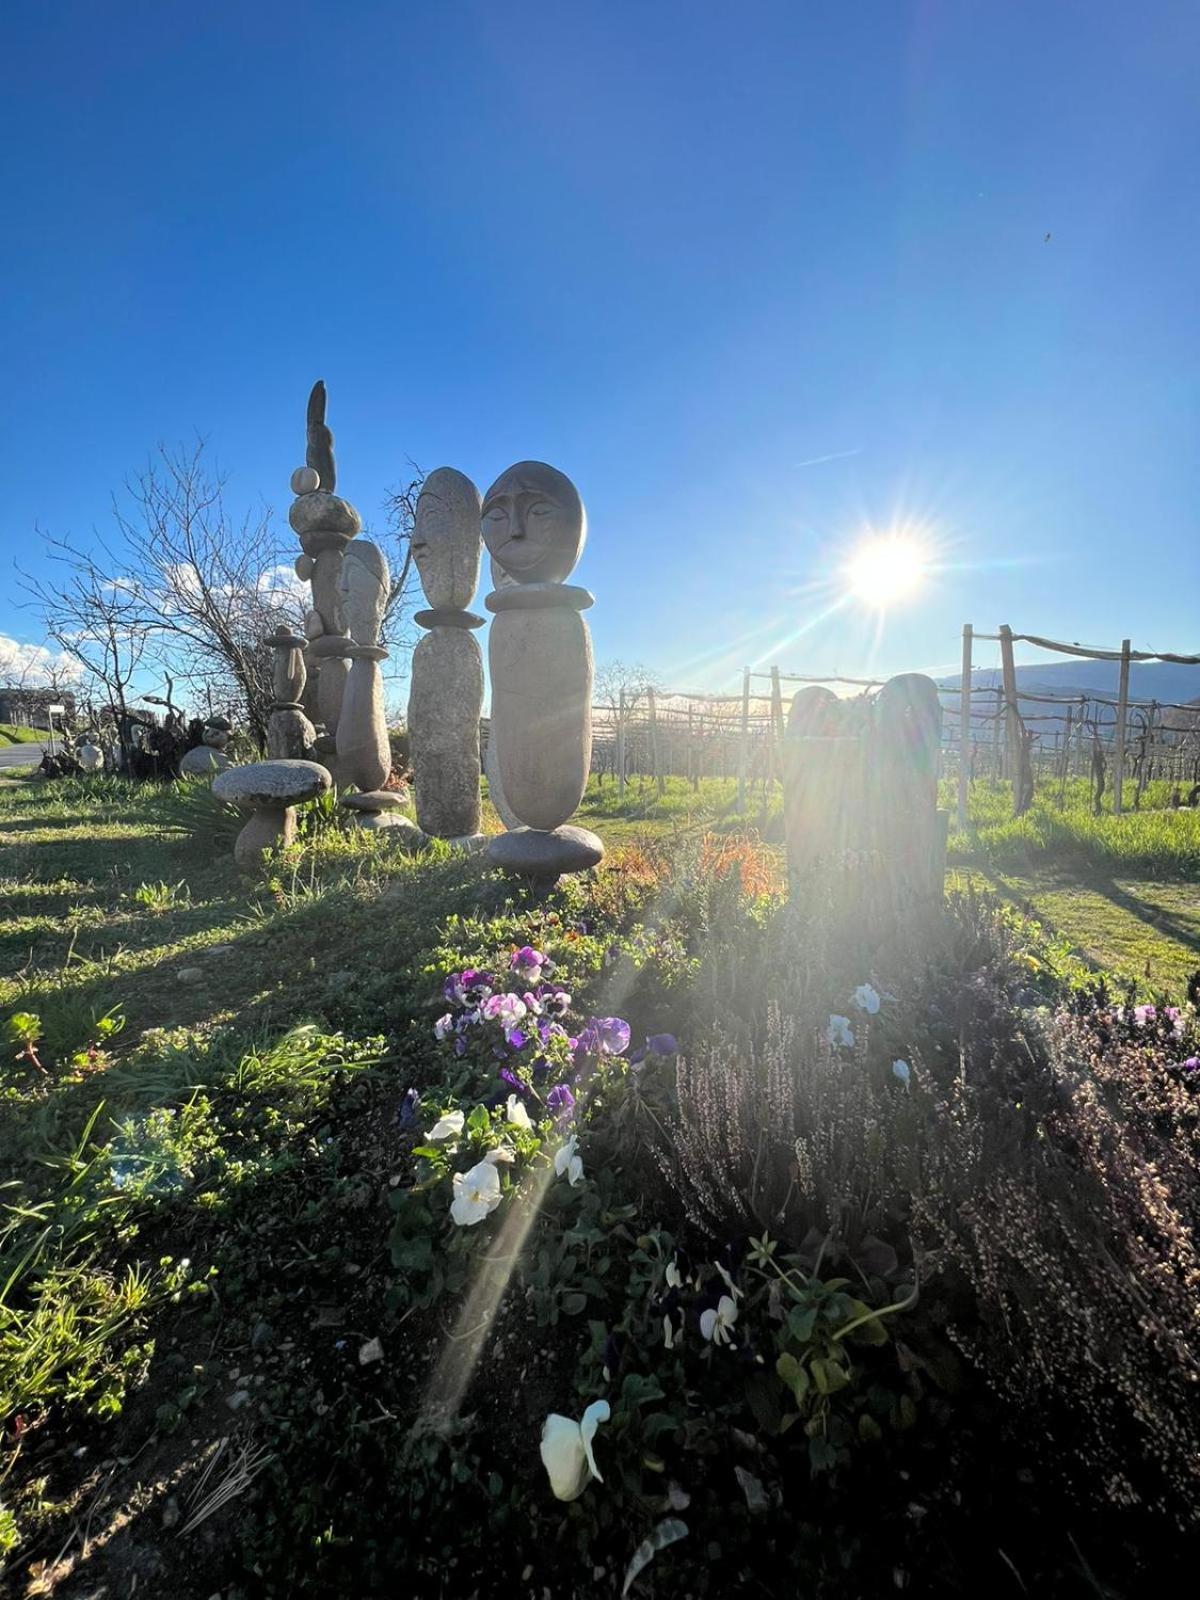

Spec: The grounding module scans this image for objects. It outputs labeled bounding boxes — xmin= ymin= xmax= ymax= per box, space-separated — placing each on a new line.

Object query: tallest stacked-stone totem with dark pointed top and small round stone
xmin=288 ymin=379 xmax=363 ymax=768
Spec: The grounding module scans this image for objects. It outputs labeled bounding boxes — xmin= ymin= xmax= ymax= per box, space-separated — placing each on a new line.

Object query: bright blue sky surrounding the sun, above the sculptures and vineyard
xmin=0 ymin=0 xmax=1200 ymax=688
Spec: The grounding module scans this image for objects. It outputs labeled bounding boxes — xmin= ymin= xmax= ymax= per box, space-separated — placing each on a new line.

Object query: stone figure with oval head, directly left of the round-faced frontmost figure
xmin=408 ymin=467 xmax=483 ymax=846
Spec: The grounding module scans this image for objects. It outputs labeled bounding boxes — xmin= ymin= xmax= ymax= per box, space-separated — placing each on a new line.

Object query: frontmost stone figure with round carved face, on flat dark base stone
xmin=482 ymin=461 xmax=605 ymax=882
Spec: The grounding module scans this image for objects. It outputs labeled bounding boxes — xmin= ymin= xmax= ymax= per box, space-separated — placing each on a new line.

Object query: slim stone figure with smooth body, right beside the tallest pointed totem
xmin=334 ymin=539 xmax=392 ymax=790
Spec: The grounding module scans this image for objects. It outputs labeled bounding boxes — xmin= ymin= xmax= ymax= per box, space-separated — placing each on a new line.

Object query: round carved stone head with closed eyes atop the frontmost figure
xmin=483 ymin=461 xmax=587 ymax=584
